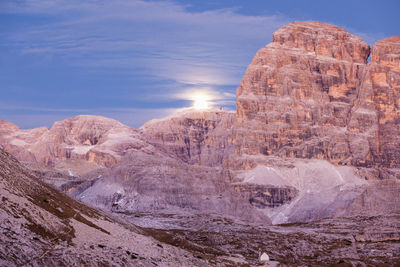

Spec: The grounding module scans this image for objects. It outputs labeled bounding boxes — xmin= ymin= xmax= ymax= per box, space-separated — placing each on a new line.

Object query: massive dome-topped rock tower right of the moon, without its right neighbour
xmin=236 ymin=22 xmax=369 ymax=162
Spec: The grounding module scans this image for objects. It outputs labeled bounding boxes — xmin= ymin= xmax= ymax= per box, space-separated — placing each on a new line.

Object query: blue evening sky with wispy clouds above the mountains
xmin=0 ymin=0 xmax=400 ymax=128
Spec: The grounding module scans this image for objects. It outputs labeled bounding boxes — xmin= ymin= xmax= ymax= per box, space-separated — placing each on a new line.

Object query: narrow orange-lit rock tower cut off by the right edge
xmin=362 ymin=36 xmax=400 ymax=168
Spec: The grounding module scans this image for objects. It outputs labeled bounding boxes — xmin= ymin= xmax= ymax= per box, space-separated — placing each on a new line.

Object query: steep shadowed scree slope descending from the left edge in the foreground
xmin=0 ymin=149 xmax=207 ymax=266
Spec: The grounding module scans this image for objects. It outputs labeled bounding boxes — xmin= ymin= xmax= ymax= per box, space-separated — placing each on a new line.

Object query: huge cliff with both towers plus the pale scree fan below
xmin=225 ymin=22 xmax=400 ymax=223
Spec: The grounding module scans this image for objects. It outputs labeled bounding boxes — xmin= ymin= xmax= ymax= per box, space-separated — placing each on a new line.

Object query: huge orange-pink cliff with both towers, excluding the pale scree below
xmin=235 ymin=22 xmax=400 ymax=171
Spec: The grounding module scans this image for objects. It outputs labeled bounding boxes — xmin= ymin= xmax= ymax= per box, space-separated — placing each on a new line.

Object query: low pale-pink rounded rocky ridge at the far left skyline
xmin=0 ymin=116 xmax=147 ymax=170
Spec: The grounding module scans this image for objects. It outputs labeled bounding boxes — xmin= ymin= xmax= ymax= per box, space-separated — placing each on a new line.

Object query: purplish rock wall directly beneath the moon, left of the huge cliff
xmin=139 ymin=109 xmax=235 ymax=166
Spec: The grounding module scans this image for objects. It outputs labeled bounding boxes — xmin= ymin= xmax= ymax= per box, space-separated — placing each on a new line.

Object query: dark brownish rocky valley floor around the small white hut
xmin=130 ymin=214 xmax=400 ymax=266
